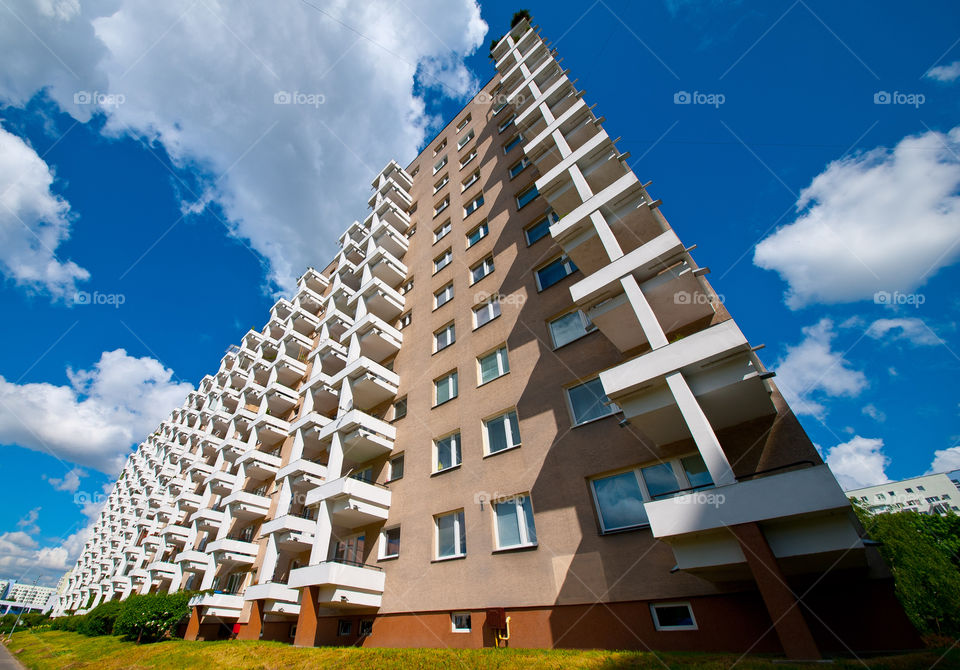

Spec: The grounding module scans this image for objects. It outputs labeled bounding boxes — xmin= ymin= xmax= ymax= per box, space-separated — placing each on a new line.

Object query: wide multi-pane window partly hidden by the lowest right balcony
xmin=590 ymin=454 xmax=713 ymax=533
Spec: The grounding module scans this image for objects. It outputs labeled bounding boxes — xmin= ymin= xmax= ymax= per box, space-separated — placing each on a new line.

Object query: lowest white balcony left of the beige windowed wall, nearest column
xmin=288 ymin=561 xmax=384 ymax=609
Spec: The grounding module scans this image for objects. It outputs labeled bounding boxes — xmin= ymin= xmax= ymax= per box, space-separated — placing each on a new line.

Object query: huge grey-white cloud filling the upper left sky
xmin=0 ymin=0 xmax=487 ymax=289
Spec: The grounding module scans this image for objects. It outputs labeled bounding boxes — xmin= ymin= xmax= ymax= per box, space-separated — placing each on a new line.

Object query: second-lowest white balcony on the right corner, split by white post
xmin=600 ymin=321 xmax=776 ymax=445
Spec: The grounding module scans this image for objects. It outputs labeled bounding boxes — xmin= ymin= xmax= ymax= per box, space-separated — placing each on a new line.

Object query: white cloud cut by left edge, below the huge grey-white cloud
xmin=0 ymin=125 xmax=90 ymax=298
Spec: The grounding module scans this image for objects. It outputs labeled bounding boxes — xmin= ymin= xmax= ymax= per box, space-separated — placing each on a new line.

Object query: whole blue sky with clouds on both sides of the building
xmin=0 ymin=0 xmax=960 ymax=581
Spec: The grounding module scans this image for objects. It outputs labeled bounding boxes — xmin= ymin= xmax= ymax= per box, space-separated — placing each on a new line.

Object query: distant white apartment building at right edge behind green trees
xmin=847 ymin=473 xmax=960 ymax=515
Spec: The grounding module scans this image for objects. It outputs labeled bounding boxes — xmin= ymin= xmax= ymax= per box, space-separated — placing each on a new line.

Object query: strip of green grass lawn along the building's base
xmin=7 ymin=630 xmax=960 ymax=670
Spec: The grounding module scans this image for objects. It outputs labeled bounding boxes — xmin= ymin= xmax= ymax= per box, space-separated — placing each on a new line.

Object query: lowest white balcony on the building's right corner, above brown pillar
xmin=644 ymin=465 xmax=865 ymax=580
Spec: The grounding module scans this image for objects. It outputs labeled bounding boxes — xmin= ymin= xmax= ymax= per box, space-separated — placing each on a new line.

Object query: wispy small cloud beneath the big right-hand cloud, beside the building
xmin=776 ymin=319 xmax=867 ymax=418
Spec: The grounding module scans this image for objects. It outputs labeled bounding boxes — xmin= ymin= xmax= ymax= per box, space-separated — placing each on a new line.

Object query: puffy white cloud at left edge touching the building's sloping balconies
xmin=0 ymin=349 xmax=192 ymax=474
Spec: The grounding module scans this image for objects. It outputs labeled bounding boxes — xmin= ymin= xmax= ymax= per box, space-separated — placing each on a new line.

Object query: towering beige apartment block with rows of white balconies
xmin=58 ymin=21 xmax=918 ymax=658
